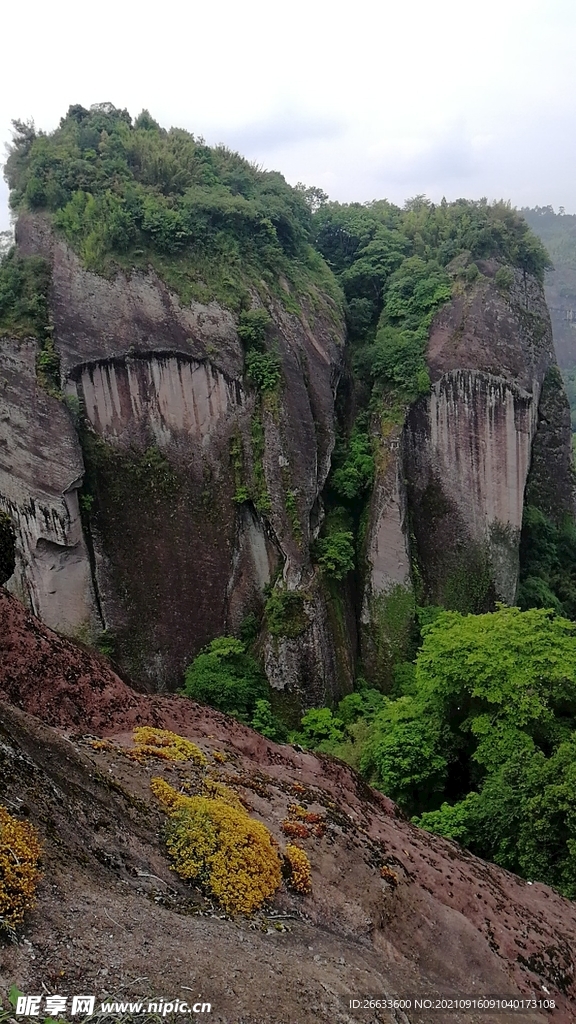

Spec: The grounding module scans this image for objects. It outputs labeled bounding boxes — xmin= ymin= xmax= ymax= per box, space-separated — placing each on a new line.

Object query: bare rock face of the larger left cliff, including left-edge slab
xmin=0 ymin=215 xmax=342 ymax=697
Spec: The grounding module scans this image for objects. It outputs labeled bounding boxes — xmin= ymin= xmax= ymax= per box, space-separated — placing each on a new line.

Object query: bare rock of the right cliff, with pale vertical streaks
xmin=363 ymin=262 xmax=574 ymax=678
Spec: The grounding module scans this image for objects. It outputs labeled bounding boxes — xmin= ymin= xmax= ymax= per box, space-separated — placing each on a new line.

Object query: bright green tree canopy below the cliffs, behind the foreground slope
xmin=298 ymin=607 xmax=576 ymax=898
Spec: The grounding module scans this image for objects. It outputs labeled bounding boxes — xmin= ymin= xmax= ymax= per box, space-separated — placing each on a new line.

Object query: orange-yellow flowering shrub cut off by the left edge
xmin=0 ymin=806 xmax=42 ymax=928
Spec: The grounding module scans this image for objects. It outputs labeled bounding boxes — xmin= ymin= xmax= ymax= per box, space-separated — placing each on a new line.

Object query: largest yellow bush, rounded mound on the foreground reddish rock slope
xmin=151 ymin=778 xmax=280 ymax=913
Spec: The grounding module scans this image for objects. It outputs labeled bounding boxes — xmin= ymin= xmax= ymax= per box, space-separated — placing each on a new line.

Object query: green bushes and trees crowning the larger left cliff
xmin=5 ymin=103 xmax=339 ymax=309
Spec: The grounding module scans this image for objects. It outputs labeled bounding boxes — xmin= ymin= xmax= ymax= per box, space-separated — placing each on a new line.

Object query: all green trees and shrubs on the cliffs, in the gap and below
xmin=0 ymin=104 xmax=576 ymax=897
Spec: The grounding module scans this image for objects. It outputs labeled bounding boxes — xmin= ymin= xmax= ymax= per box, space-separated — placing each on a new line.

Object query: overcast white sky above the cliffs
xmin=0 ymin=0 xmax=576 ymax=228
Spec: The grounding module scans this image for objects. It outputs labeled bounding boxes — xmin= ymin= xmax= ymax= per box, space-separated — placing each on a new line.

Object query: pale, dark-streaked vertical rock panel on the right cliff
xmin=406 ymin=370 xmax=539 ymax=605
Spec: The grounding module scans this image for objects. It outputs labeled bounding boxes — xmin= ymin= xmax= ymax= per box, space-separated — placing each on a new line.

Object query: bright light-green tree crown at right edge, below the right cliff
xmin=416 ymin=607 xmax=576 ymax=766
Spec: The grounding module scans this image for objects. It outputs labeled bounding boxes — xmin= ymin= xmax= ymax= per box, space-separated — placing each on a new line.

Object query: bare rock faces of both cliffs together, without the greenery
xmin=0 ymin=212 xmax=573 ymax=703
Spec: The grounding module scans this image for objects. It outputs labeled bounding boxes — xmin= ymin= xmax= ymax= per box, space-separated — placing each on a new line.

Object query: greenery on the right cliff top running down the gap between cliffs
xmin=313 ymin=196 xmax=549 ymax=593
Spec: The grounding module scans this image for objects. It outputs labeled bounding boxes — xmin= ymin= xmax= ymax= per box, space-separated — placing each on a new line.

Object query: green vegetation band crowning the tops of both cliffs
xmin=5 ymin=103 xmax=548 ymax=323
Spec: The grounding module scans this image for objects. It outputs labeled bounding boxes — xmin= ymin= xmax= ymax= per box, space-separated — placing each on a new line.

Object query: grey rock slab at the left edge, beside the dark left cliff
xmin=0 ymin=338 xmax=97 ymax=636
